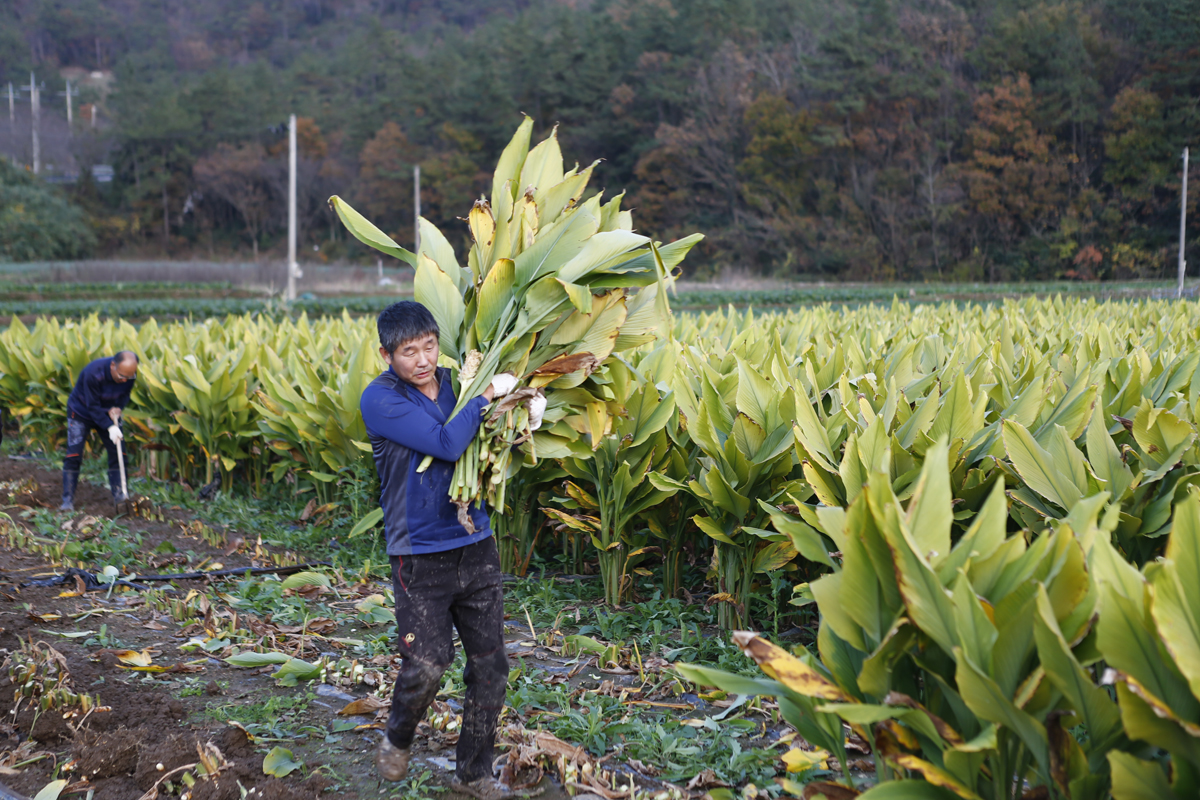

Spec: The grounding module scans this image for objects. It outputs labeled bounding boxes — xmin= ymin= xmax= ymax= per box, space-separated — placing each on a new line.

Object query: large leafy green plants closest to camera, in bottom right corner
xmin=678 ymin=443 xmax=1200 ymax=800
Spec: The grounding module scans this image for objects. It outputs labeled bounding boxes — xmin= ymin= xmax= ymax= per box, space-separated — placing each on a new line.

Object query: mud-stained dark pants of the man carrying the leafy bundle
xmin=388 ymin=537 xmax=509 ymax=782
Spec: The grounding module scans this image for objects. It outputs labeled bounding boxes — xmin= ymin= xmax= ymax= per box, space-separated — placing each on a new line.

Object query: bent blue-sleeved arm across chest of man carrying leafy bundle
xmin=362 ymin=391 xmax=487 ymax=462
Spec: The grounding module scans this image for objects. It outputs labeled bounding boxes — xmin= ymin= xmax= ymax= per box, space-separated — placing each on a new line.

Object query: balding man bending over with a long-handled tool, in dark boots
xmin=60 ymin=350 xmax=138 ymax=511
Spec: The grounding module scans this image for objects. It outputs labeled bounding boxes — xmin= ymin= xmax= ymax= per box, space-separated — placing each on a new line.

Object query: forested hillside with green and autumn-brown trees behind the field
xmin=0 ymin=0 xmax=1200 ymax=281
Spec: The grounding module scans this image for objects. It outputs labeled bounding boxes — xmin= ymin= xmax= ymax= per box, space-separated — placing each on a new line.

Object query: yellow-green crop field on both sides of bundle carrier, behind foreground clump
xmin=0 ymin=299 xmax=1200 ymax=609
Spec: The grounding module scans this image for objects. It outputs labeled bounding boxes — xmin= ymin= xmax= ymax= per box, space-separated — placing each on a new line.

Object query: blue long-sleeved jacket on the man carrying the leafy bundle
xmin=359 ymin=368 xmax=492 ymax=555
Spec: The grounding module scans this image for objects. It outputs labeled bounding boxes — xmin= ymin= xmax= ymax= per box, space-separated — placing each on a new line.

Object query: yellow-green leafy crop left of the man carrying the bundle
xmin=0 ymin=314 xmax=382 ymax=503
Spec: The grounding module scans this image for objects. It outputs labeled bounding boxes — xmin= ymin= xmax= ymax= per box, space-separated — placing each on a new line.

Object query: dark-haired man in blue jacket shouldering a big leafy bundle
xmin=361 ymin=301 xmax=540 ymax=800
